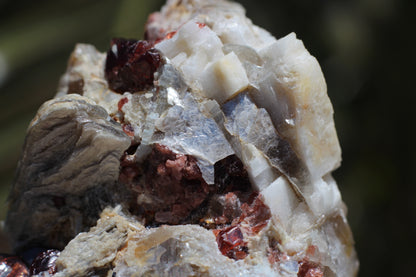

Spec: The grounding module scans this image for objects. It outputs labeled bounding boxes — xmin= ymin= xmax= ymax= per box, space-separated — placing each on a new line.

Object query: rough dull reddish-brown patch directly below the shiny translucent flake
xmin=127 ymin=144 xmax=209 ymax=224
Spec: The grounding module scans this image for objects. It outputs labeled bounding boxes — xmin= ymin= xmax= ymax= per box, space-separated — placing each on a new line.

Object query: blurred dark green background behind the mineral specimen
xmin=0 ymin=0 xmax=416 ymax=277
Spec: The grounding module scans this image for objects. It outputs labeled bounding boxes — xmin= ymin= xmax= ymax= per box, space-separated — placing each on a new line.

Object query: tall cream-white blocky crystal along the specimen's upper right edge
xmin=258 ymin=33 xmax=341 ymax=180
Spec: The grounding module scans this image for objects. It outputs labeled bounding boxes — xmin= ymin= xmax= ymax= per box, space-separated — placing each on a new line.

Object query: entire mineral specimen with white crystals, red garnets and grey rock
xmin=0 ymin=0 xmax=358 ymax=277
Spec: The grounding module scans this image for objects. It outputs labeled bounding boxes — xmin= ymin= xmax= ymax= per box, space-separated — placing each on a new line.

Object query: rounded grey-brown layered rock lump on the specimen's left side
xmin=7 ymin=94 xmax=130 ymax=249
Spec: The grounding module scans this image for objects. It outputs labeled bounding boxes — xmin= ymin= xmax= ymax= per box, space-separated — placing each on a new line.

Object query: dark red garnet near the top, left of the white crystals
xmin=105 ymin=38 xmax=162 ymax=93
